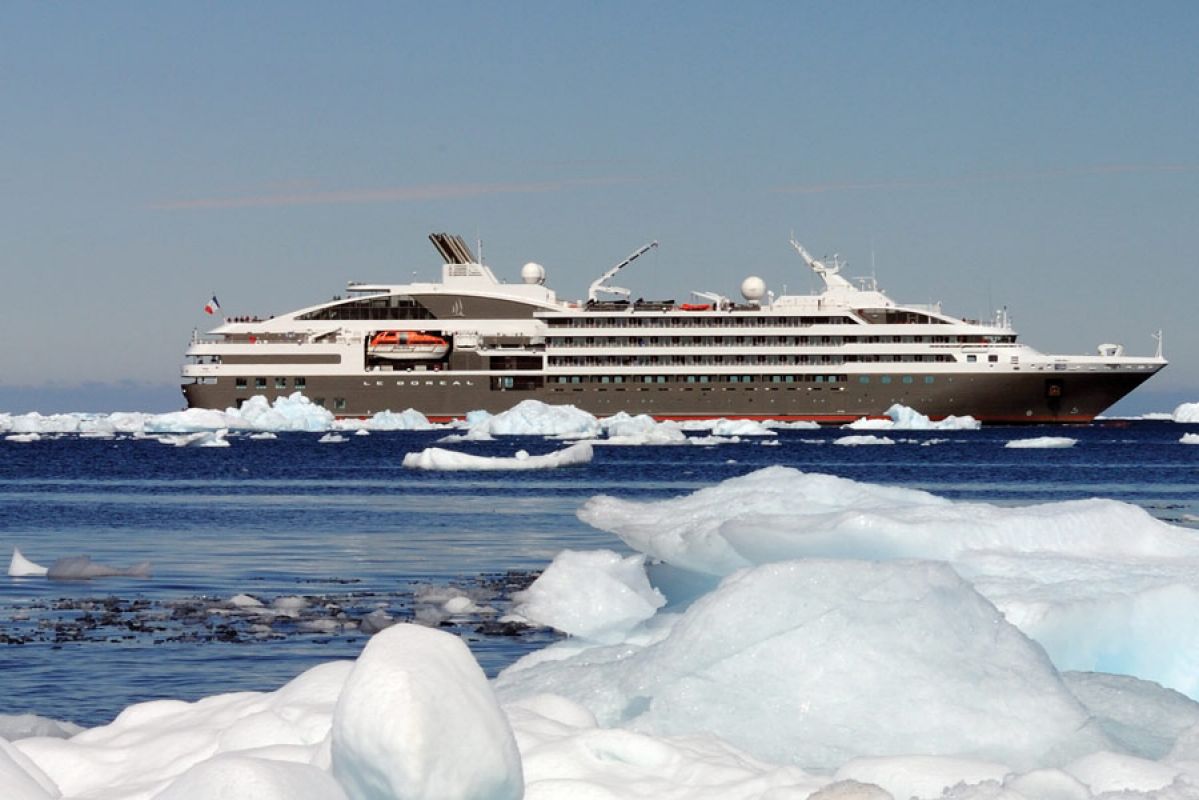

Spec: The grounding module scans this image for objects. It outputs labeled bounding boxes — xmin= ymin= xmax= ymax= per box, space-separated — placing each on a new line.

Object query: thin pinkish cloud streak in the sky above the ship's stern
xmin=150 ymin=178 xmax=639 ymax=211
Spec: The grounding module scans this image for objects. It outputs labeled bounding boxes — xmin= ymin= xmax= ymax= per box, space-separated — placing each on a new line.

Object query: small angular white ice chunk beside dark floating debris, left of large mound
xmin=513 ymin=551 xmax=665 ymax=644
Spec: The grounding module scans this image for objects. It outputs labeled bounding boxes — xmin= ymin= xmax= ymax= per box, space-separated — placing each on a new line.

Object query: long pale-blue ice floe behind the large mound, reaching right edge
xmin=579 ymin=467 xmax=1199 ymax=697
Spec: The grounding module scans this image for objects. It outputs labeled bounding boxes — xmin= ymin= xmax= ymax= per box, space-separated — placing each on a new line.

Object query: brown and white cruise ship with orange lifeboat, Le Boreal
xmin=182 ymin=234 xmax=1165 ymax=423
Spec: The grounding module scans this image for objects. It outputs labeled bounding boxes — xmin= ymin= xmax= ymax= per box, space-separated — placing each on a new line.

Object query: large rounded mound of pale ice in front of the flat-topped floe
xmin=496 ymin=559 xmax=1110 ymax=769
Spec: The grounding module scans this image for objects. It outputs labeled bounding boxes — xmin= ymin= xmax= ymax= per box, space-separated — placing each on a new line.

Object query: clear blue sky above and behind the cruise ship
xmin=0 ymin=1 xmax=1199 ymax=411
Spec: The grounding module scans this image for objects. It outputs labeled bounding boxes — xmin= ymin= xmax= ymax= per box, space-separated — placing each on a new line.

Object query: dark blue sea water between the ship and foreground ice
xmin=0 ymin=421 xmax=1199 ymax=726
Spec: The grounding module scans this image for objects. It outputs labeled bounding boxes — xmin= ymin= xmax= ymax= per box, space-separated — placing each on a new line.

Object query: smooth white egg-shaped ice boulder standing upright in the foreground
xmin=332 ymin=624 xmax=524 ymax=800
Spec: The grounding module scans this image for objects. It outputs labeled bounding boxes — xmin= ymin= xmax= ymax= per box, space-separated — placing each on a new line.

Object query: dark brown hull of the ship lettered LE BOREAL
xmin=183 ymin=369 xmax=1153 ymax=423
